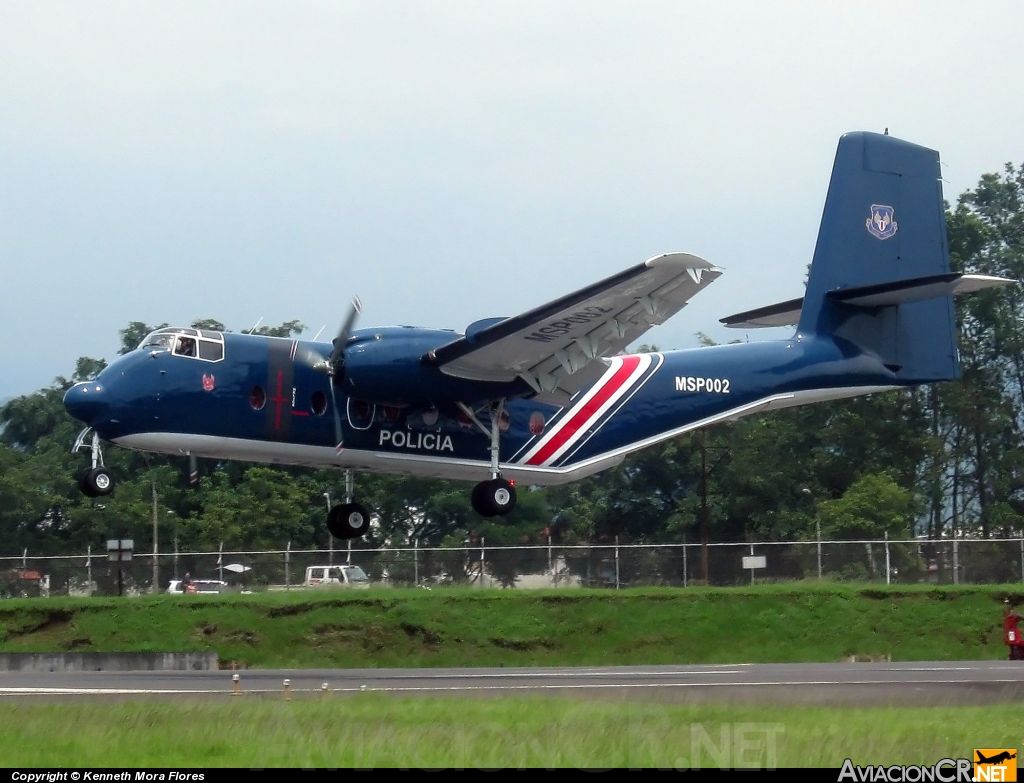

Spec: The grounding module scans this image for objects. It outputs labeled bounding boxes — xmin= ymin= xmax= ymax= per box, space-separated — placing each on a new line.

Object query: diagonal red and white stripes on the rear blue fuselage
xmin=521 ymin=354 xmax=653 ymax=466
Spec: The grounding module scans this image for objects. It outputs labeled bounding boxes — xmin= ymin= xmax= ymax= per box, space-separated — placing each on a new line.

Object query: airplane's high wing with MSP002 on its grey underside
xmin=423 ymin=253 xmax=722 ymax=405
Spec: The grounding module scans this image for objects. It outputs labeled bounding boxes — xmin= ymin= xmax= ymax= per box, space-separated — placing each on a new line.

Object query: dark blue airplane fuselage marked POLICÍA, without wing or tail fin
xmin=67 ymin=330 xmax=904 ymax=485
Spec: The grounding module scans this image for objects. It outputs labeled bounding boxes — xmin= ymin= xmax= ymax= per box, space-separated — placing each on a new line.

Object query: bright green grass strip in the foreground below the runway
xmin=0 ymin=694 xmax=1024 ymax=769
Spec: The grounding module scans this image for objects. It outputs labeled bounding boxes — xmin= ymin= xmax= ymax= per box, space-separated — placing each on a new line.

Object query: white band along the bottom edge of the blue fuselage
xmin=114 ymin=386 xmax=902 ymax=485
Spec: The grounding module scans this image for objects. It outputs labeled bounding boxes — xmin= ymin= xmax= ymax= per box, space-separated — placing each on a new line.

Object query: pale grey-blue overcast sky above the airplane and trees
xmin=0 ymin=0 xmax=1024 ymax=400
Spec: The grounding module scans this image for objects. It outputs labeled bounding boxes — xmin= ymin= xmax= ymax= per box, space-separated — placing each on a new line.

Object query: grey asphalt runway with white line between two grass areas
xmin=0 ymin=661 xmax=1024 ymax=704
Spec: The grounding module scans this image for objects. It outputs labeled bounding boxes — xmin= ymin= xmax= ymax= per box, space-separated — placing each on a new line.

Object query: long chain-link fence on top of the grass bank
xmin=0 ymin=538 xmax=1024 ymax=598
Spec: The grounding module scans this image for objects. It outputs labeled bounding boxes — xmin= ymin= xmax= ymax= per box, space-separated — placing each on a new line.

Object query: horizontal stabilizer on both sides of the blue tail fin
xmin=721 ymin=272 xmax=1017 ymax=329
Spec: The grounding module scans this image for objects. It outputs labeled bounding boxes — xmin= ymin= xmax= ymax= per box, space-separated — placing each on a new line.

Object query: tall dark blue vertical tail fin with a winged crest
xmin=798 ymin=133 xmax=958 ymax=382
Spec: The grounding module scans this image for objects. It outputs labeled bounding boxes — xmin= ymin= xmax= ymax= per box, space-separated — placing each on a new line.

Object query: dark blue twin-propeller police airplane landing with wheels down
xmin=63 ymin=132 xmax=1016 ymax=538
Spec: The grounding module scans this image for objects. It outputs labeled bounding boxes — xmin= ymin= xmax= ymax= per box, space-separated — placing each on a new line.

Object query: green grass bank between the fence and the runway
xmin=0 ymin=584 xmax=1024 ymax=667
